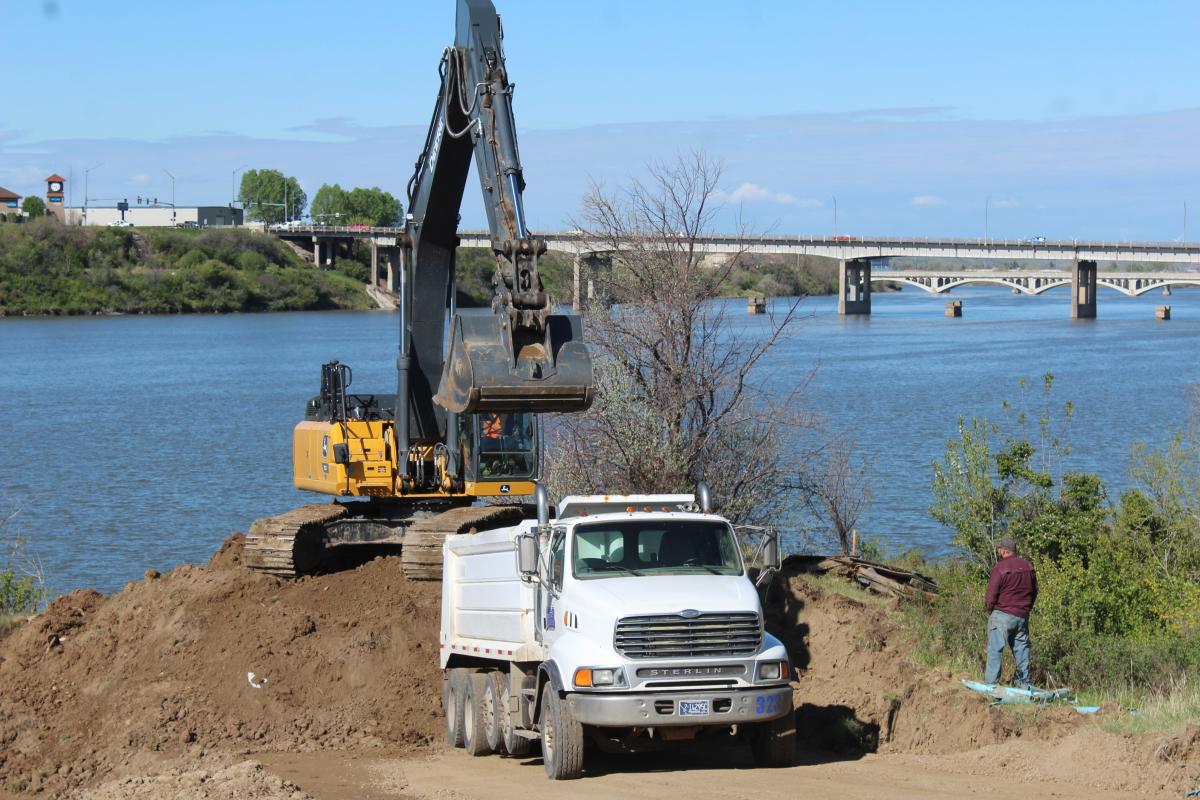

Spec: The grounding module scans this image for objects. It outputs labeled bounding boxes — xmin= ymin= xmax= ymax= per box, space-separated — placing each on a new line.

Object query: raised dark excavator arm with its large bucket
xmin=397 ymin=0 xmax=594 ymax=438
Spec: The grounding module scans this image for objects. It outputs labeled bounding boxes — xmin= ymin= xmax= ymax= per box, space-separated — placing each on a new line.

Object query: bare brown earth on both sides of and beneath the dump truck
xmin=0 ymin=537 xmax=1200 ymax=800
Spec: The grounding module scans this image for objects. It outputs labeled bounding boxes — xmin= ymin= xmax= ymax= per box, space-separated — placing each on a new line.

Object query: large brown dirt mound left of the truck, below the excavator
xmin=0 ymin=539 xmax=440 ymax=796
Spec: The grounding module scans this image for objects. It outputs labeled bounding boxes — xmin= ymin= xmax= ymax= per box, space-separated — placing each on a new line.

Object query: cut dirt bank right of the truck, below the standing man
xmin=764 ymin=564 xmax=1200 ymax=793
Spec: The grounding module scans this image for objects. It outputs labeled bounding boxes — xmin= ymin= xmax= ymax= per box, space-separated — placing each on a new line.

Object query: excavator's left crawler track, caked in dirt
xmin=242 ymin=503 xmax=347 ymax=578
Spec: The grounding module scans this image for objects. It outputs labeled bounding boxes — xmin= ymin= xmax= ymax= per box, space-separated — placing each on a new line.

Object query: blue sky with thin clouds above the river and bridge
xmin=0 ymin=0 xmax=1200 ymax=241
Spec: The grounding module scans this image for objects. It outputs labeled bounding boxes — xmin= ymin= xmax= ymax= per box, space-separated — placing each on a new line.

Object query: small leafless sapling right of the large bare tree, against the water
xmin=797 ymin=438 xmax=871 ymax=555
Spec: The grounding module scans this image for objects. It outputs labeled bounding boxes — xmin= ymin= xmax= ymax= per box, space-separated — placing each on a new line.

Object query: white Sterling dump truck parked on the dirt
xmin=439 ymin=487 xmax=796 ymax=780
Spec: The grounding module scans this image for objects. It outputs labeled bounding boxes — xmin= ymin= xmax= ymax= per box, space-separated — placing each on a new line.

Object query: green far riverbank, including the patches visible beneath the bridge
xmin=0 ymin=219 xmax=838 ymax=317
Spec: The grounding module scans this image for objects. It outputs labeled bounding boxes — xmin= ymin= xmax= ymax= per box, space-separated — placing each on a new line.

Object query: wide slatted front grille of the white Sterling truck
xmin=613 ymin=613 xmax=762 ymax=658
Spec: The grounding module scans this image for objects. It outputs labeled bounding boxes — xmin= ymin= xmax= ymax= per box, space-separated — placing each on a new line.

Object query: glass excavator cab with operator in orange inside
xmin=457 ymin=411 xmax=541 ymax=497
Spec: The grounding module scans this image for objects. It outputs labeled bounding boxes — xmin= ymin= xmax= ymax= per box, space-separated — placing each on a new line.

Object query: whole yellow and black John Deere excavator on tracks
xmin=242 ymin=0 xmax=594 ymax=579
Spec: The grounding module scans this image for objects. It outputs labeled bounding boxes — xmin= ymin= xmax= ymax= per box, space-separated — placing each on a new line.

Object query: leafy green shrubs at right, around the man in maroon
xmin=911 ymin=375 xmax=1200 ymax=690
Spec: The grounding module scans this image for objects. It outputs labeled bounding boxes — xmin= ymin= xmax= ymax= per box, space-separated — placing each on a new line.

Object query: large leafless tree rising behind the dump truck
xmin=547 ymin=154 xmax=811 ymax=524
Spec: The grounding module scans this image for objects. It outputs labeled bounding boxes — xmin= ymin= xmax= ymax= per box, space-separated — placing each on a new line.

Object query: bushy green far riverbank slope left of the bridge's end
xmin=0 ymin=219 xmax=374 ymax=317
